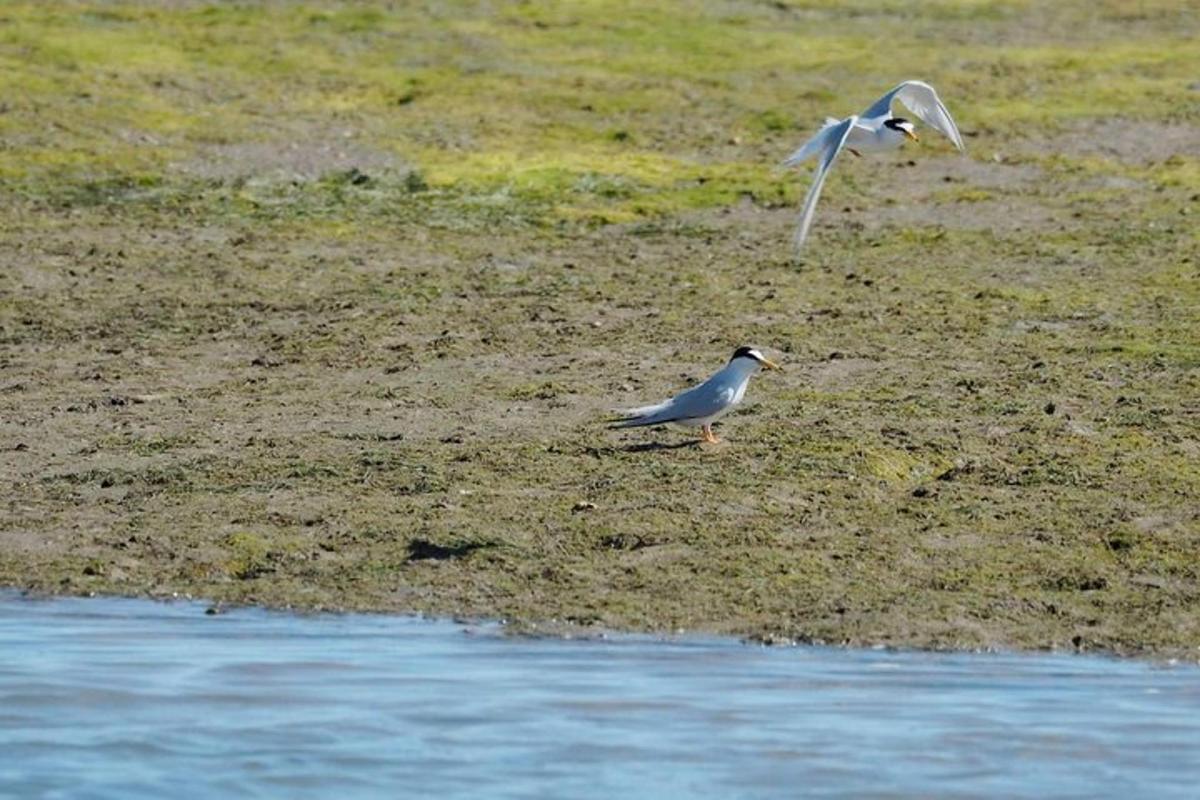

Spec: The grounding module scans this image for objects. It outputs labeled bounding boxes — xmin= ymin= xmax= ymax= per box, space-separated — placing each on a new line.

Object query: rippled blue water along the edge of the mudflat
xmin=0 ymin=594 xmax=1200 ymax=799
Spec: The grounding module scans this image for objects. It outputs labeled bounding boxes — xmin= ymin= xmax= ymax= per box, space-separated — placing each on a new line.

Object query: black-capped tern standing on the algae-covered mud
xmin=612 ymin=347 xmax=782 ymax=444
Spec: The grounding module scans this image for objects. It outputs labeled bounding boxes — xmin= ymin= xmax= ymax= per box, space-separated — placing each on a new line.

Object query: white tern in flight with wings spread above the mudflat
xmin=784 ymin=80 xmax=965 ymax=249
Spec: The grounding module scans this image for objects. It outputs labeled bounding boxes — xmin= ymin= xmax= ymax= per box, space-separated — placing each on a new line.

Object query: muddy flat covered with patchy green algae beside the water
xmin=0 ymin=2 xmax=1200 ymax=655
